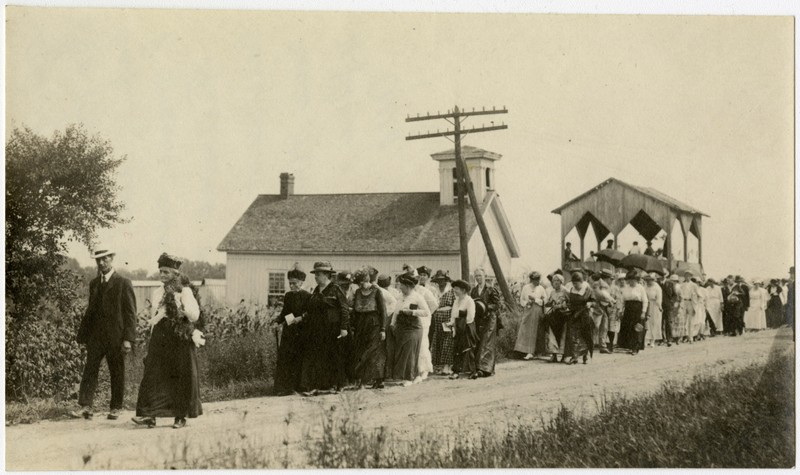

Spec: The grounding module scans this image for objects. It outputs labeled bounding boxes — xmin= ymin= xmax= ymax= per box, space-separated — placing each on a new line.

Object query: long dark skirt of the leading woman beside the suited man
xmin=136 ymin=318 xmax=203 ymax=418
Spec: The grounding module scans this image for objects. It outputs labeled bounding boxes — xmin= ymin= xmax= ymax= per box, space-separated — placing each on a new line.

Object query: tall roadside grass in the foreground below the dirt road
xmin=156 ymin=352 xmax=795 ymax=469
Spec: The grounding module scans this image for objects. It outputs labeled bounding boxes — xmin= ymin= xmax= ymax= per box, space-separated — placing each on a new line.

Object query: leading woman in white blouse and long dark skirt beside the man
xmin=133 ymin=253 xmax=203 ymax=429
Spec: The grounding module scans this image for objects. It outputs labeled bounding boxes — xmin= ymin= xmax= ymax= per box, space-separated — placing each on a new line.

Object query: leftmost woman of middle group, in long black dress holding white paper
xmin=275 ymin=265 xmax=311 ymax=396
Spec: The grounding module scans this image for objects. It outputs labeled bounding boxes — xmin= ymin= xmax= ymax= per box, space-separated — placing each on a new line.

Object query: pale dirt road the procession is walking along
xmin=6 ymin=329 xmax=794 ymax=470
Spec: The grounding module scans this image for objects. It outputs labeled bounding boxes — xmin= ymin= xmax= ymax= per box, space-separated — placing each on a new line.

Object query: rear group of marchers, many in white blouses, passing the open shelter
xmin=515 ymin=267 xmax=794 ymax=364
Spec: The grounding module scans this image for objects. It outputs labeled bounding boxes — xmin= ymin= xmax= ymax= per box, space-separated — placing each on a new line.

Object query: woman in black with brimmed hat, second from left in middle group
xmin=300 ymin=262 xmax=350 ymax=396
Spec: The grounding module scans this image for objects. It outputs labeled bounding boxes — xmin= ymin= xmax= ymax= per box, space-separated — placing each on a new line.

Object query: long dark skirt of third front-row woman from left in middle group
xmin=353 ymin=312 xmax=386 ymax=384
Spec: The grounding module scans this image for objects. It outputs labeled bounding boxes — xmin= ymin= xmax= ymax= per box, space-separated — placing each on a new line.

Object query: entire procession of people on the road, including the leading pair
xmin=71 ymin=245 xmax=794 ymax=429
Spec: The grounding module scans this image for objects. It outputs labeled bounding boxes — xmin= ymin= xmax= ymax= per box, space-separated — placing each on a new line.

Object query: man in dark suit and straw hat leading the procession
xmin=70 ymin=248 xmax=136 ymax=420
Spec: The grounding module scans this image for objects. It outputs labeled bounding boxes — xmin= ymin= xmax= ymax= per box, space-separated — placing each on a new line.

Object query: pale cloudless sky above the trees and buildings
xmin=6 ymin=7 xmax=794 ymax=278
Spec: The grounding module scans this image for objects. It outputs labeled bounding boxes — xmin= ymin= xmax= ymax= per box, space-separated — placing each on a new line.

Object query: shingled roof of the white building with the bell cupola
xmin=217 ymin=192 xmax=519 ymax=257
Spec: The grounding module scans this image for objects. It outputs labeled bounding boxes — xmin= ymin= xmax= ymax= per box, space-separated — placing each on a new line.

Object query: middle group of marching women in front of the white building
xmin=275 ymin=262 xmax=502 ymax=396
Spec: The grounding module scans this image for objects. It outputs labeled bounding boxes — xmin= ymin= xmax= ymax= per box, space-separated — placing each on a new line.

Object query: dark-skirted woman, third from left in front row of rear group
xmin=565 ymin=271 xmax=595 ymax=365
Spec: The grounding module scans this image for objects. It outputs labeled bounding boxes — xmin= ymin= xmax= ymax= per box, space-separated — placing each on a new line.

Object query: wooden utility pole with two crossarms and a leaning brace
xmin=406 ymin=106 xmax=514 ymax=306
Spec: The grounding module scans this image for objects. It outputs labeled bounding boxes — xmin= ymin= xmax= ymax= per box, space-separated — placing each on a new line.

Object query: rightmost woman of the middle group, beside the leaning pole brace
xmin=470 ymin=268 xmax=502 ymax=378
